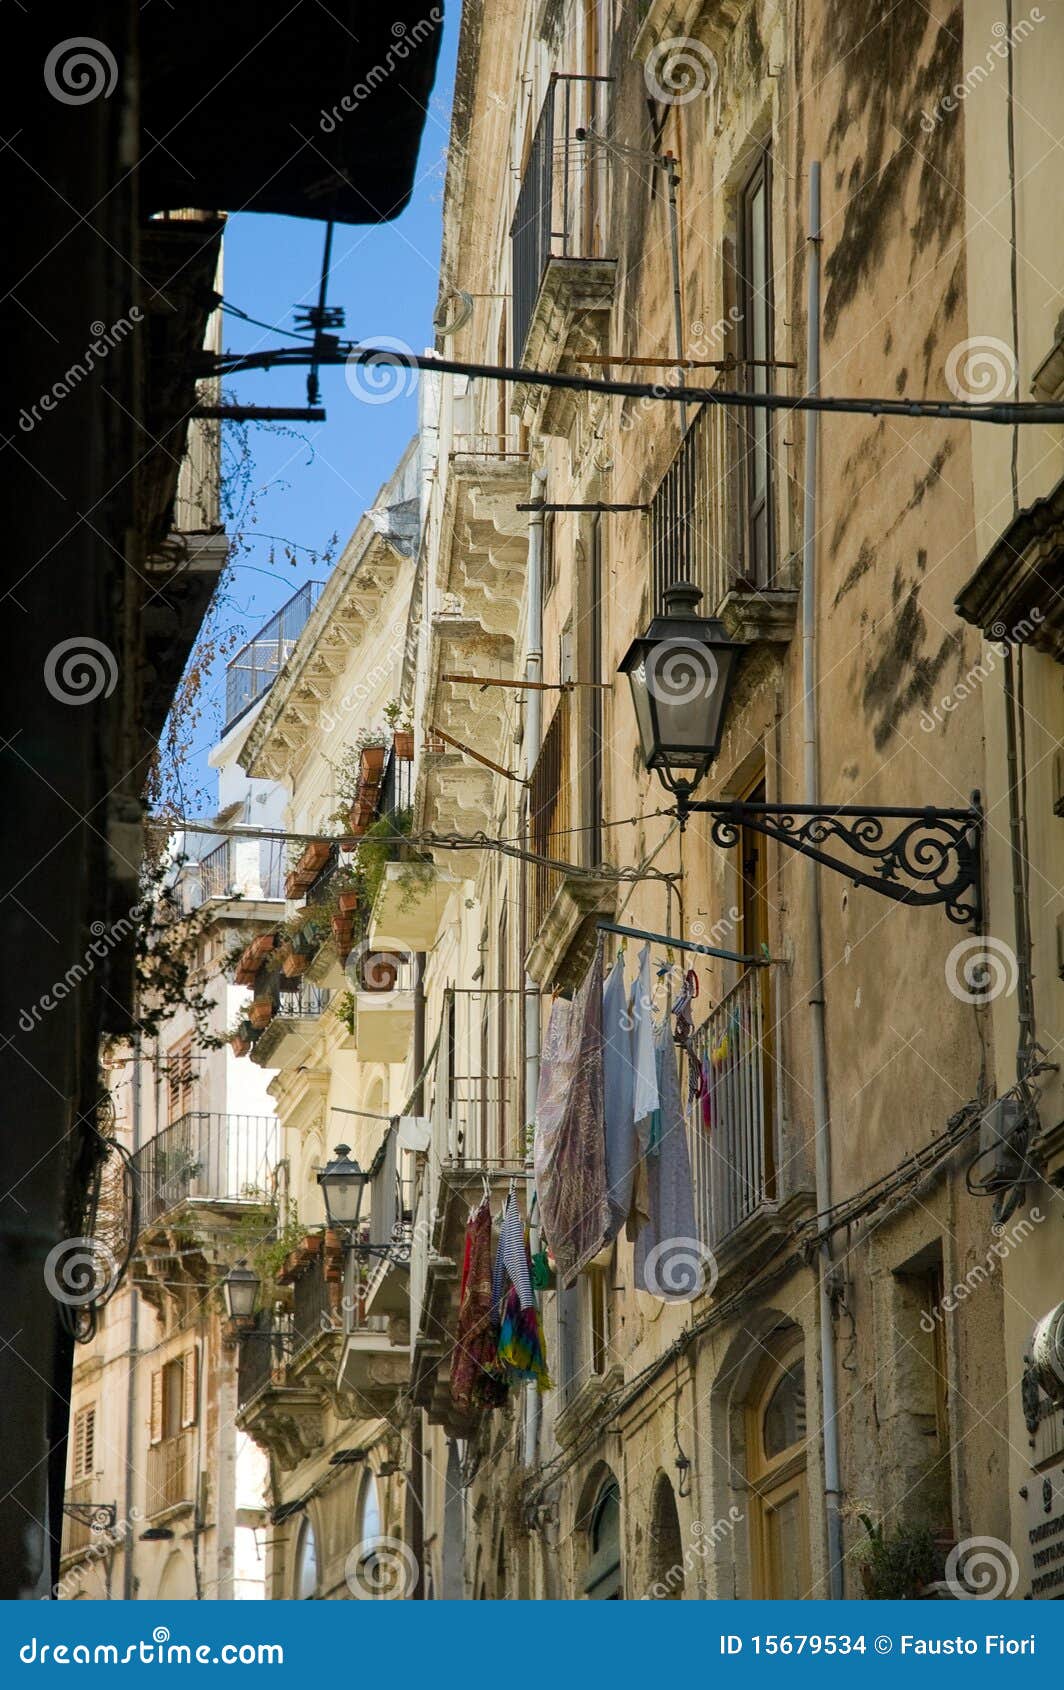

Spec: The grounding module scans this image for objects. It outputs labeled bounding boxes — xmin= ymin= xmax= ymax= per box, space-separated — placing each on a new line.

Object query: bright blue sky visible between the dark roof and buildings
xmin=191 ymin=16 xmax=459 ymax=781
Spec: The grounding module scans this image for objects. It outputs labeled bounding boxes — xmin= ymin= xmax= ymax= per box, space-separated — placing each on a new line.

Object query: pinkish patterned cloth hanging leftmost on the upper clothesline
xmin=532 ymin=945 xmax=610 ymax=1284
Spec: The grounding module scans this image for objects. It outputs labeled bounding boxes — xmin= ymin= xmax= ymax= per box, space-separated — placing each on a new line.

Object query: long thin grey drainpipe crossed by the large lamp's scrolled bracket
xmin=802 ymin=161 xmax=843 ymax=1602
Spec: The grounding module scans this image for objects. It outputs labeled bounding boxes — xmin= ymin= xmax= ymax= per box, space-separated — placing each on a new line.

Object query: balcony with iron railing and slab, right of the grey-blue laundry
xmin=691 ymin=967 xmax=809 ymax=1273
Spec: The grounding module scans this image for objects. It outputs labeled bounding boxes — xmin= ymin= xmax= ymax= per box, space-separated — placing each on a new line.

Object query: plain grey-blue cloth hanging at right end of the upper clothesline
xmin=635 ymin=1022 xmax=708 ymax=1301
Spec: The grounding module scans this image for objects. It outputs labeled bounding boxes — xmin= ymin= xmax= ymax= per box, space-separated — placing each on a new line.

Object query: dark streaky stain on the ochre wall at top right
xmin=817 ymin=0 xmax=964 ymax=340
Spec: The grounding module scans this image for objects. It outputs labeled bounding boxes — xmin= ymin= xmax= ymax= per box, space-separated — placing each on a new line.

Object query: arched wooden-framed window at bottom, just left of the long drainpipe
xmin=746 ymin=1347 xmax=811 ymax=1600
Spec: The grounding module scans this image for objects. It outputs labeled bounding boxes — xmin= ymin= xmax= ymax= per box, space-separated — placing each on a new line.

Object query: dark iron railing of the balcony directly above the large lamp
xmin=650 ymin=368 xmax=772 ymax=615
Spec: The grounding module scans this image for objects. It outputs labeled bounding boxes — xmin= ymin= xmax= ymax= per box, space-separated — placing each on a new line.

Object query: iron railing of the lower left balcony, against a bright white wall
xmin=133 ymin=1110 xmax=280 ymax=1222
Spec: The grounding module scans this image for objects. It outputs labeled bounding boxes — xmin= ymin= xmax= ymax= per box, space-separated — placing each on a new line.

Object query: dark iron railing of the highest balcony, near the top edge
xmin=510 ymin=76 xmax=610 ymax=363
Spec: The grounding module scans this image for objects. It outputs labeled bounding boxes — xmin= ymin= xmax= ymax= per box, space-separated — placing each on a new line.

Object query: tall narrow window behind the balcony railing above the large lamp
xmin=736 ymin=150 xmax=775 ymax=586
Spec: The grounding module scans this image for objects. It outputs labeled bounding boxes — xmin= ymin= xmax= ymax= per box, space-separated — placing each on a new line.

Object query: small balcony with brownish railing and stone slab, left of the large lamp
xmin=525 ymin=693 xmax=616 ymax=985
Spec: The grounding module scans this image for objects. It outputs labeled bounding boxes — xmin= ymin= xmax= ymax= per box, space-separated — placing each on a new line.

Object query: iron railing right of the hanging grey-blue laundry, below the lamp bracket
xmin=691 ymin=968 xmax=777 ymax=1249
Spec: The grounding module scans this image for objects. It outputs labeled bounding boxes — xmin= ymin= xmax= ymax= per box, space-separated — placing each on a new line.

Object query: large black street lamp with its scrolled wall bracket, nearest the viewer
xmin=620 ymin=581 xmax=983 ymax=931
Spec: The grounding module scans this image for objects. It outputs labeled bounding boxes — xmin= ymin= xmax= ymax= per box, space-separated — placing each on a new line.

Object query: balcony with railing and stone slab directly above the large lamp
xmin=650 ymin=376 xmax=797 ymax=644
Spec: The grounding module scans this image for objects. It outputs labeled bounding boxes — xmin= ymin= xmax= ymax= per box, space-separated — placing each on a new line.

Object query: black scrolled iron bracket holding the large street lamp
xmin=674 ymin=782 xmax=983 ymax=931
